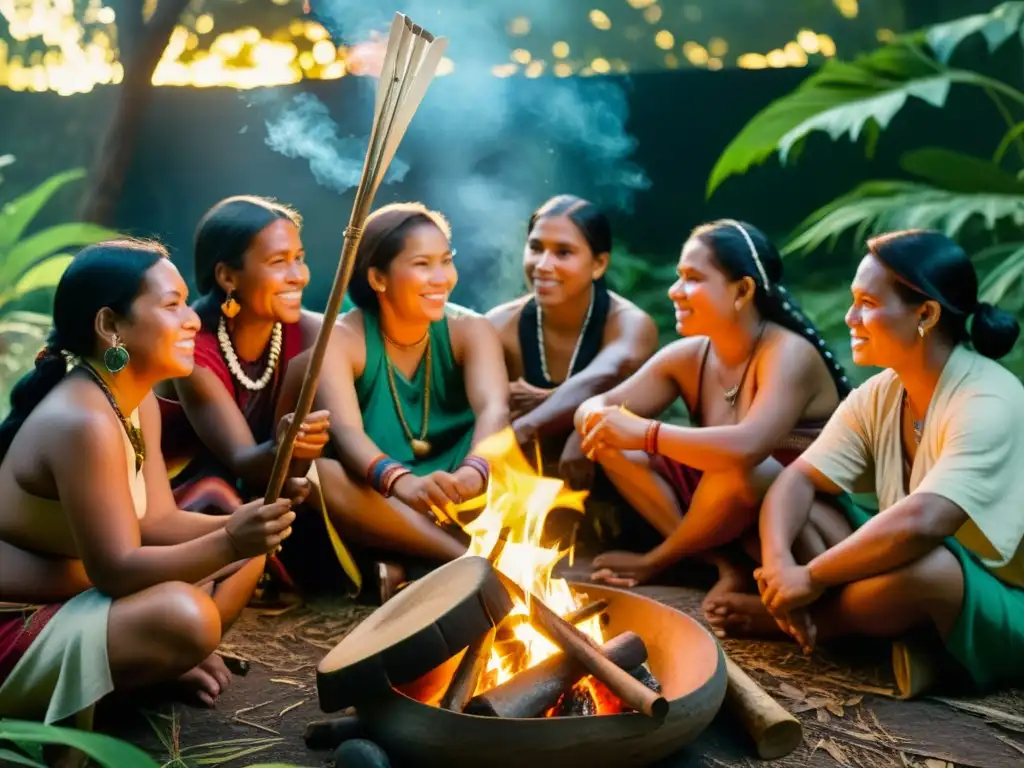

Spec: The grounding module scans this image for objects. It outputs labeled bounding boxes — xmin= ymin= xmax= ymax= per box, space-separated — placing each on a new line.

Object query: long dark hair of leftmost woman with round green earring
xmin=0 ymin=239 xmax=169 ymax=462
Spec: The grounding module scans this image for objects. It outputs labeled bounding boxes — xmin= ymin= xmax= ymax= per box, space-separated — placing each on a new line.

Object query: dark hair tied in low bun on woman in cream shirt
xmin=867 ymin=229 xmax=1021 ymax=359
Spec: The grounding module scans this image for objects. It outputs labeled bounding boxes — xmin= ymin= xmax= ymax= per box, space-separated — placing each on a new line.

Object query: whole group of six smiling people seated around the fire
xmin=0 ymin=196 xmax=1024 ymax=723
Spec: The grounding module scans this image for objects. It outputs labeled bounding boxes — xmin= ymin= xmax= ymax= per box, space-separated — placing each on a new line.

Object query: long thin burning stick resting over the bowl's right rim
xmin=496 ymin=568 xmax=669 ymax=719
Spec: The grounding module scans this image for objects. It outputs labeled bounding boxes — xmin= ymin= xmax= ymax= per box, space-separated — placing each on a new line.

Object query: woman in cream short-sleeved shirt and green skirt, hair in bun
xmin=753 ymin=231 xmax=1024 ymax=695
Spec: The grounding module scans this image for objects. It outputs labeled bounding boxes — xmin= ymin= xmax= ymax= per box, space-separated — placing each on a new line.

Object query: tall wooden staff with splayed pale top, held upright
xmin=264 ymin=13 xmax=447 ymax=504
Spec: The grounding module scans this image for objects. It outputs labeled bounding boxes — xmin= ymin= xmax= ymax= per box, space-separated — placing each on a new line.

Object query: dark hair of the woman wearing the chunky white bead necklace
xmin=193 ymin=195 xmax=302 ymax=329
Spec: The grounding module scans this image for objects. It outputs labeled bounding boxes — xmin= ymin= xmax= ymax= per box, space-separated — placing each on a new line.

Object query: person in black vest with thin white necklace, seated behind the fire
xmin=487 ymin=195 xmax=657 ymax=488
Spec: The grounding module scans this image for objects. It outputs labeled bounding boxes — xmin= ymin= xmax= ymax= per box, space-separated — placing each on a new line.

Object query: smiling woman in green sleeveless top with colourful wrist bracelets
xmin=285 ymin=203 xmax=509 ymax=599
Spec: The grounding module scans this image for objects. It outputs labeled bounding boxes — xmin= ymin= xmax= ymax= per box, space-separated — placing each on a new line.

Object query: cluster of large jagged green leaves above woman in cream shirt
xmin=708 ymin=0 xmax=1024 ymax=368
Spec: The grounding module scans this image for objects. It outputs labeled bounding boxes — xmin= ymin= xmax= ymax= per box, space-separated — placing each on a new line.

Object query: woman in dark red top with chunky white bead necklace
xmin=160 ymin=196 xmax=357 ymax=584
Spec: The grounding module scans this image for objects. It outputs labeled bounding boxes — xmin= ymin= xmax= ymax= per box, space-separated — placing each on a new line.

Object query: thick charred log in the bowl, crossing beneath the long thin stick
xmin=465 ymin=632 xmax=647 ymax=718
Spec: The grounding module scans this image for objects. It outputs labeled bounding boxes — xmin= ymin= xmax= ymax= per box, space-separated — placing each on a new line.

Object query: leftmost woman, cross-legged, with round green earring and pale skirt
xmin=0 ymin=241 xmax=302 ymax=724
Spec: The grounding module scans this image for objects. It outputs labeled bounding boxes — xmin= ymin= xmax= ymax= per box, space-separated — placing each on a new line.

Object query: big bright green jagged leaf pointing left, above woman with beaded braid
xmin=708 ymin=40 xmax=950 ymax=197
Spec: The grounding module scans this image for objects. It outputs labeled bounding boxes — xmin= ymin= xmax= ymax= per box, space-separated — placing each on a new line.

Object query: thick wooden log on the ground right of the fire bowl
xmin=725 ymin=656 xmax=804 ymax=760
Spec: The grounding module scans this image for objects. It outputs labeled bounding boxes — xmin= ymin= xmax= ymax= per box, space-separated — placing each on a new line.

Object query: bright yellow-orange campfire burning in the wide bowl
xmin=413 ymin=430 xmax=664 ymax=717
